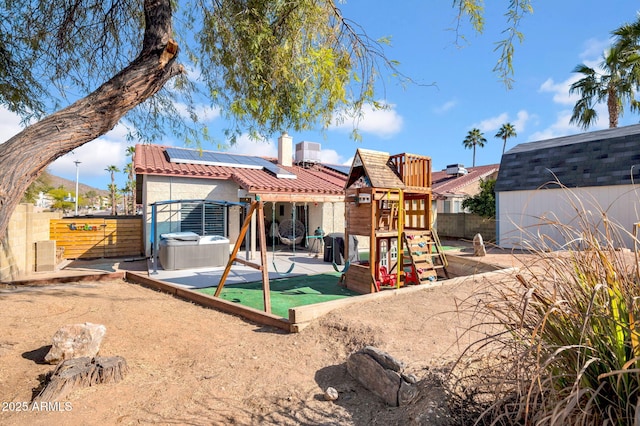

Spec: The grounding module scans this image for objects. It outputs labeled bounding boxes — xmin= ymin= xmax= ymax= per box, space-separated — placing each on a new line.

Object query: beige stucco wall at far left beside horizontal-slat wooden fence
xmin=0 ymin=204 xmax=62 ymax=281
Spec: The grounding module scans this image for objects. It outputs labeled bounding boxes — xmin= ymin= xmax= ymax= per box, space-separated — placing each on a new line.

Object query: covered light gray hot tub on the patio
xmin=158 ymin=232 xmax=229 ymax=271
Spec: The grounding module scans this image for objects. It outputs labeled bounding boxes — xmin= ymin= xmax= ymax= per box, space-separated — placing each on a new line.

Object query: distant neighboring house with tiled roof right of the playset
xmin=431 ymin=164 xmax=500 ymax=213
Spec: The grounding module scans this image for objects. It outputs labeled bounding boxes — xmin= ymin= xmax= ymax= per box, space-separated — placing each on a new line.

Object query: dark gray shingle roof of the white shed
xmin=496 ymin=124 xmax=640 ymax=192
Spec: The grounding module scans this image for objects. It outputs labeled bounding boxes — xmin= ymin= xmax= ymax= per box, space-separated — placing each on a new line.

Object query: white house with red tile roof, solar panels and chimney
xmin=134 ymin=133 xmax=348 ymax=255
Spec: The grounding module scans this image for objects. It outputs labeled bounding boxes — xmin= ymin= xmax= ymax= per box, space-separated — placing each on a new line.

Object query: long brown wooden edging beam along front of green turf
xmin=125 ymin=271 xmax=293 ymax=332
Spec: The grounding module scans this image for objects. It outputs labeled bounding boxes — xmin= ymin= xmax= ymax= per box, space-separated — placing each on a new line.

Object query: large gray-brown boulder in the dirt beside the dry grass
xmin=347 ymin=346 xmax=418 ymax=407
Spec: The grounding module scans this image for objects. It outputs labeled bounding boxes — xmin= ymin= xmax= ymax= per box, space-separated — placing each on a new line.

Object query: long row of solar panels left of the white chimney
xmin=165 ymin=148 xmax=296 ymax=179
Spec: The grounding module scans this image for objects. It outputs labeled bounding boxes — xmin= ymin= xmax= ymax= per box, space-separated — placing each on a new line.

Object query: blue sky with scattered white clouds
xmin=0 ymin=0 xmax=640 ymax=190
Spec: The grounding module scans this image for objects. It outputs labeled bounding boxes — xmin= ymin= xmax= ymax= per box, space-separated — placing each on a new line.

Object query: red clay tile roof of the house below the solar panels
xmin=134 ymin=145 xmax=347 ymax=195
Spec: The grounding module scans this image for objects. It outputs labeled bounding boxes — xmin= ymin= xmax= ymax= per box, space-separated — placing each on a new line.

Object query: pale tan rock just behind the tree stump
xmin=44 ymin=322 xmax=107 ymax=364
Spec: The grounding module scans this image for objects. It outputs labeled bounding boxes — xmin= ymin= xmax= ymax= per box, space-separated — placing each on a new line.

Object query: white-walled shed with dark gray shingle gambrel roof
xmin=496 ymin=125 xmax=640 ymax=248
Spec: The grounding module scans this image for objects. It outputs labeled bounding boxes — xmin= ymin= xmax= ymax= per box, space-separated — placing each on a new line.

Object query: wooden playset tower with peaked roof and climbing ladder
xmin=342 ymin=149 xmax=448 ymax=294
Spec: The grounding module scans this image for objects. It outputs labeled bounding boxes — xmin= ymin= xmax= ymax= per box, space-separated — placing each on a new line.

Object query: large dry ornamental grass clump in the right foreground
xmin=449 ymin=190 xmax=640 ymax=425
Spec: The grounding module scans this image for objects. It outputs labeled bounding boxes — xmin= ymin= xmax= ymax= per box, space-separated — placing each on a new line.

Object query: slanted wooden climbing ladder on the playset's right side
xmin=402 ymin=231 xmax=449 ymax=284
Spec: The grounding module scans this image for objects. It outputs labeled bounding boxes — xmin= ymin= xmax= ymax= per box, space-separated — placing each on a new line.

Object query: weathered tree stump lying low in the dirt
xmin=33 ymin=356 xmax=127 ymax=402
